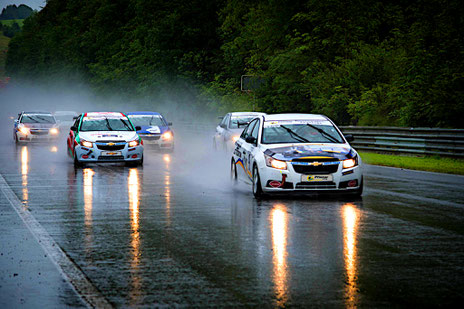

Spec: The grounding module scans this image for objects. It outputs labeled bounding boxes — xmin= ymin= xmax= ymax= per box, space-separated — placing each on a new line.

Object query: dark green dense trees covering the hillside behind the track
xmin=7 ymin=0 xmax=464 ymax=127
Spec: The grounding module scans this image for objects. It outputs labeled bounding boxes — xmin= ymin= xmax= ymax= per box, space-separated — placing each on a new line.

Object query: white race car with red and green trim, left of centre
xmin=67 ymin=112 xmax=143 ymax=166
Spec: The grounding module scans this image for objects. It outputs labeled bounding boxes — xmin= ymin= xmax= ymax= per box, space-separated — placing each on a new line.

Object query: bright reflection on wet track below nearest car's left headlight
xmin=270 ymin=204 xmax=288 ymax=307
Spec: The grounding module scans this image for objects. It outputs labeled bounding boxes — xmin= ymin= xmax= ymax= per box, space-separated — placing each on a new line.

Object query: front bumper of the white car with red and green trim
xmin=75 ymin=143 xmax=143 ymax=163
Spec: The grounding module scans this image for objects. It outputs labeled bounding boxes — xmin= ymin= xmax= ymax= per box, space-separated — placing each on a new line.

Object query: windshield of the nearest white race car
xmin=262 ymin=120 xmax=344 ymax=144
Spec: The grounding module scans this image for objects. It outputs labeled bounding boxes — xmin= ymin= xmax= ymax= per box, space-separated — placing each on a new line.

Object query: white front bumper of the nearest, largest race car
xmin=259 ymin=162 xmax=362 ymax=193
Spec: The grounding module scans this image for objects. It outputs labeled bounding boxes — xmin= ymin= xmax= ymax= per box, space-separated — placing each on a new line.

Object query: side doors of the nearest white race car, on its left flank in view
xmin=235 ymin=119 xmax=258 ymax=183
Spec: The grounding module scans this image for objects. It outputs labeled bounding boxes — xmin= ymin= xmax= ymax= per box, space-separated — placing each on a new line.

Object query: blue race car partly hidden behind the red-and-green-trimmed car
xmin=127 ymin=112 xmax=174 ymax=150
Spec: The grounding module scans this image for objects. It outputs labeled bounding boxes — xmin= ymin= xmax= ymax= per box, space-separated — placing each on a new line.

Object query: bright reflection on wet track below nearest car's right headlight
xmin=342 ymin=203 xmax=359 ymax=308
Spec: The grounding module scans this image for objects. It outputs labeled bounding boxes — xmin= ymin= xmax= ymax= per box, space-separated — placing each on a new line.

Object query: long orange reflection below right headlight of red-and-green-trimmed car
xmin=127 ymin=168 xmax=142 ymax=306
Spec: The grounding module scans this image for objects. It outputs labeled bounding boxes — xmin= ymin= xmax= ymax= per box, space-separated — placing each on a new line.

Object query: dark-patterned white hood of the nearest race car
xmin=264 ymin=144 xmax=356 ymax=161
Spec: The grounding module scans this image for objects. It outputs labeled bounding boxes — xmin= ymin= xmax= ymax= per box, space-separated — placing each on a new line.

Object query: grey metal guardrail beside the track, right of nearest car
xmin=340 ymin=126 xmax=464 ymax=158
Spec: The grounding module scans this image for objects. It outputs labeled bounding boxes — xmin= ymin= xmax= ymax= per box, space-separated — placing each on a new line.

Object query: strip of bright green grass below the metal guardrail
xmin=360 ymin=152 xmax=464 ymax=175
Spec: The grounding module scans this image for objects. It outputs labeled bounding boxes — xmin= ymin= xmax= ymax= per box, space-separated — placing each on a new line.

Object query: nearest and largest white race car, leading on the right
xmin=231 ymin=114 xmax=363 ymax=197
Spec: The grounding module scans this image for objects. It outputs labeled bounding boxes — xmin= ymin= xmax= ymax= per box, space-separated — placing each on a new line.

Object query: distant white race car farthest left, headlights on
xmin=13 ymin=112 xmax=59 ymax=143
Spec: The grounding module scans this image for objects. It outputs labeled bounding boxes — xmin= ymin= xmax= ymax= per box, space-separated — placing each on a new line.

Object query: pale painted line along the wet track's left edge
xmin=0 ymin=174 xmax=112 ymax=308
